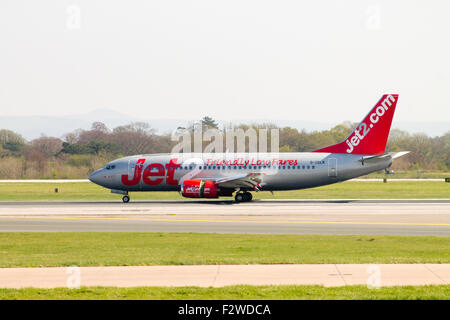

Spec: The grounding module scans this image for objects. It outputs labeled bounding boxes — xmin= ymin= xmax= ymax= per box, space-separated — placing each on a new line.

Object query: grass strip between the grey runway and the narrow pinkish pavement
xmin=0 ymin=232 xmax=450 ymax=267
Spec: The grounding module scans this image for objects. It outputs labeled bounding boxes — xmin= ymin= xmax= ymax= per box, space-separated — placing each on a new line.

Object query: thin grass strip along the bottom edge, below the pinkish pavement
xmin=0 ymin=285 xmax=450 ymax=300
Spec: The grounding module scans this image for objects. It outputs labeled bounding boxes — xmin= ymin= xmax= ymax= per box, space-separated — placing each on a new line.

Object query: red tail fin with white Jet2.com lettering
xmin=314 ymin=94 xmax=398 ymax=154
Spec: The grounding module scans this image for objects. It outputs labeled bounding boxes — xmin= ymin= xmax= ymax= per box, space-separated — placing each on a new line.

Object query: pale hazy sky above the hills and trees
xmin=0 ymin=0 xmax=450 ymax=122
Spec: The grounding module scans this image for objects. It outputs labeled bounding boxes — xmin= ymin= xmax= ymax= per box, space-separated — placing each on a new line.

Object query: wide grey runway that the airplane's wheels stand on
xmin=0 ymin=199 xmax=450 ymax=236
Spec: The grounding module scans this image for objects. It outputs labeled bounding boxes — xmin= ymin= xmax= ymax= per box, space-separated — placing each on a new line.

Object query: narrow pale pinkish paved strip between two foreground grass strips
xmin=0 ymin=264 xmax=450 ymax=288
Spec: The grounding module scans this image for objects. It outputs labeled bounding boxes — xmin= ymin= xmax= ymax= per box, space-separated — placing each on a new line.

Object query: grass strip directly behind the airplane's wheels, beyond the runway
xmin=0 ymin=181 xmax=450 ymax=201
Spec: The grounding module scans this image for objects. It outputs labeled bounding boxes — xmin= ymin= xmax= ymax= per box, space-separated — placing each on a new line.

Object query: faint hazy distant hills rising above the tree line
xmin=0 ymin=109 xmax=450 ymax=140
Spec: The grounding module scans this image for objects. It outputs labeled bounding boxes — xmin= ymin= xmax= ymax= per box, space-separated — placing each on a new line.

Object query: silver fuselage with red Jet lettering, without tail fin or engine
xmin=89 ymin=152 xmax=392 ymax=191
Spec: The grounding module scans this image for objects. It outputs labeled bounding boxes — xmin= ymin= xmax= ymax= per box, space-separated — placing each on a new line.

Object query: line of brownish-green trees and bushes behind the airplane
xmin=0 ymin=117 xmax=450 ymax=179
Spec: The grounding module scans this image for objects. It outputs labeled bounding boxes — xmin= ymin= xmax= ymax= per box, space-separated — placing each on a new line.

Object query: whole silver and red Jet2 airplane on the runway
xmin=89 ymin=94 xmax=408 ymax=203
